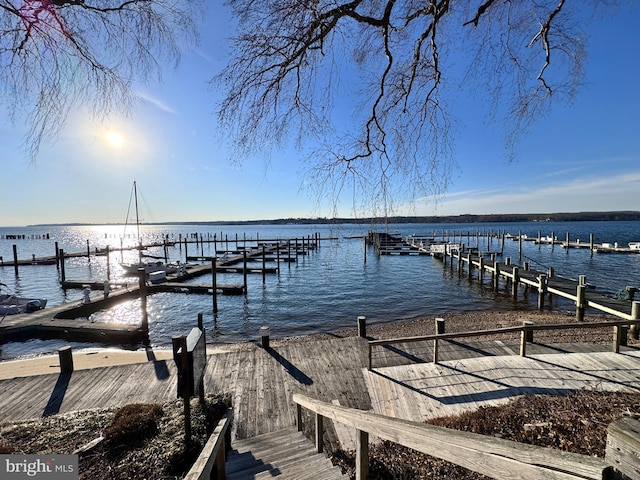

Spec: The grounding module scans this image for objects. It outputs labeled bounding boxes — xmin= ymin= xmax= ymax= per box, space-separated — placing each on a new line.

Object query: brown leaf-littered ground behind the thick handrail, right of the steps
xmin=334 ymin=390 xmax=640 ymax=480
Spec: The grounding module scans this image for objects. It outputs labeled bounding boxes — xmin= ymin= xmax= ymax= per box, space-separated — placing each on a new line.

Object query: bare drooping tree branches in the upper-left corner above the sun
xmin=0 ymin=0 xmax=201 ymax=160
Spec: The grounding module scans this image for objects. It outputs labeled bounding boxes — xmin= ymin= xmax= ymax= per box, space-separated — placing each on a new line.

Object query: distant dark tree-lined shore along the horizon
xmin=23 ymin=211 xmax=640 ymax=228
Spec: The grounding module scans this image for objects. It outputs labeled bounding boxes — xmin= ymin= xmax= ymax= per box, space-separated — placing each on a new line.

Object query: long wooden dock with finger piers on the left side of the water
xmin=0 ymin=240 xmax=317 ymax=344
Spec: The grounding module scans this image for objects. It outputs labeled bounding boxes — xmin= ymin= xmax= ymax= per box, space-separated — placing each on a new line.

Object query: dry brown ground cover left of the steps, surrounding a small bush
xmin=0 ymin=397 xmax=229 ymax=480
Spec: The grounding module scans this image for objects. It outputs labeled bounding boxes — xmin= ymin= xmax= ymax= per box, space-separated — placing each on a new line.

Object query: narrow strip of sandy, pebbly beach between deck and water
xmin=0 ymin=310 xmax=640 ymax=380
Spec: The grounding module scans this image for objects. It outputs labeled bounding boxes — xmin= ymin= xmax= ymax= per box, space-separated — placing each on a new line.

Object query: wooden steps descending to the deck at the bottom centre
xmin=226 ymin=427 xmax=348 ymax=480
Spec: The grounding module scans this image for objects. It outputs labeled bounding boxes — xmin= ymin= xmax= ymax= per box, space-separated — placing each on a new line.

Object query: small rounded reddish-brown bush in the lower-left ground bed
xmin=103 ymin=403 xmax=162 ymax=446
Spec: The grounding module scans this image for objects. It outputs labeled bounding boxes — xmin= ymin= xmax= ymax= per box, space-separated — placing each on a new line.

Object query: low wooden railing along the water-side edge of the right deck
xmin=368 ymin=319 xmax=640 ymax=370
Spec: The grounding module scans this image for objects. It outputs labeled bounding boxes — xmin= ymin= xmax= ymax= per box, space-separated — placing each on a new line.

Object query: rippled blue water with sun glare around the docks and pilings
xmin=0 ymin=222 xmax=640 ymax=359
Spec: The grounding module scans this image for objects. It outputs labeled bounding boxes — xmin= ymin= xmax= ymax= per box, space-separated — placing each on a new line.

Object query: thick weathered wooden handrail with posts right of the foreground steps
xmin=293 ymin=394 xmax=611 ymax=480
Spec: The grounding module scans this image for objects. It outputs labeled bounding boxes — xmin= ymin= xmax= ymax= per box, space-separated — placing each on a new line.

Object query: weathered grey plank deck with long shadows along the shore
xmin=0 ymin=337 xmax=640 ymax=454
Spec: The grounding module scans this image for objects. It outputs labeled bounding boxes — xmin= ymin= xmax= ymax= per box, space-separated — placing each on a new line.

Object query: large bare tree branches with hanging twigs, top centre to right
xmin=215 ymin=0 xmax=599 ymax=216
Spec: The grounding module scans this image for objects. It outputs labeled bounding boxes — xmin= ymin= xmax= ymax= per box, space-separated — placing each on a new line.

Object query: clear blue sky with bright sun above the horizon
xmin=0 ymin=2 xmax=640 ymax=226
